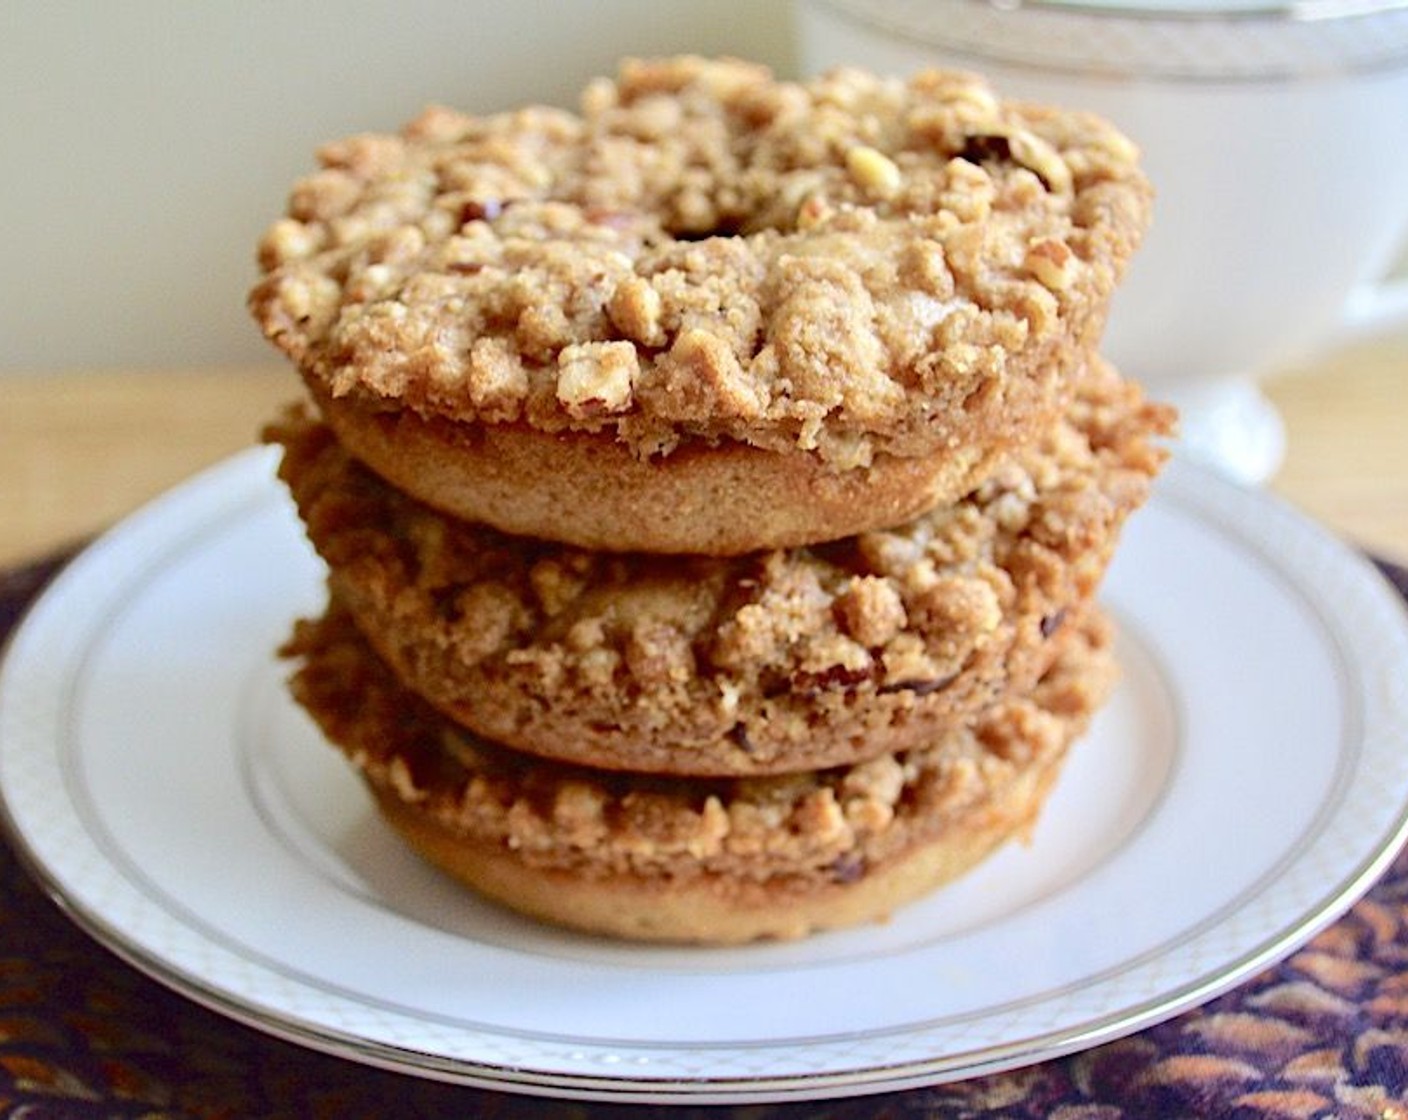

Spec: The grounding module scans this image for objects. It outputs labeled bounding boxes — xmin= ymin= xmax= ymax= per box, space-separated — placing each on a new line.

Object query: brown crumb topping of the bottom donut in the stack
xmin=286 ymin=611 xmax=1114 ymax=886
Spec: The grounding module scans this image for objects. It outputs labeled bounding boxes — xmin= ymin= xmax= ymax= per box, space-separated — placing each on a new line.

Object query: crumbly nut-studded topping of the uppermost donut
xmin=251 ymin=58 xmax=1150 ymax=555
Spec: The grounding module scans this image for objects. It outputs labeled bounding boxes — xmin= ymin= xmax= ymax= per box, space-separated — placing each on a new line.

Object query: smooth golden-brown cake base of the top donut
xmin=310 ymin=380 xmax=1002 ymax=556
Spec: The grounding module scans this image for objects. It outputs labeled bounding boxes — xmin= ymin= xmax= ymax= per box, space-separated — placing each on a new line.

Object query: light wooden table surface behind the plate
xmin=0 ymin=334 xmax=1408 ymax=565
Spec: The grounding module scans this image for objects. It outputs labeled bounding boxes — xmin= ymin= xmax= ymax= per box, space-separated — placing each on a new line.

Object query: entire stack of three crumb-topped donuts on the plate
xmin=251 ymin=58 xmax=1171 ymax=942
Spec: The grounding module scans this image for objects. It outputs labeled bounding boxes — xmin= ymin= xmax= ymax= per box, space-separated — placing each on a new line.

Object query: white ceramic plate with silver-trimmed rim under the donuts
xmin=0 ymin=451 xmax=1408 ymax=1102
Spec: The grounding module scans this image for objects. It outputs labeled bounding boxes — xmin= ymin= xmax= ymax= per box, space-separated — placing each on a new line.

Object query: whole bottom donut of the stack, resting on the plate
xmin=286 ymin=606 xmax=1115 ymax=944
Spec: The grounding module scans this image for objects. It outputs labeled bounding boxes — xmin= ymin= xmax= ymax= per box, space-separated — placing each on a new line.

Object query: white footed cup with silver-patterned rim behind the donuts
xmin=797 ymin=0 xmax=1408 ymax=482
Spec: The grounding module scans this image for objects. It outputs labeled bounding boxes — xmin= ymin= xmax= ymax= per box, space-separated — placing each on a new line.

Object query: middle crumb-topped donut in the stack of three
xmin=269 ymin=358 xmax=1170 ymax=775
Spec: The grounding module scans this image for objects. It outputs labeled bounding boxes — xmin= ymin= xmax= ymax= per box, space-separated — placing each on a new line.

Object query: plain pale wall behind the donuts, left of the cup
xmin=0 ymin=0 xmax=793 ymax=373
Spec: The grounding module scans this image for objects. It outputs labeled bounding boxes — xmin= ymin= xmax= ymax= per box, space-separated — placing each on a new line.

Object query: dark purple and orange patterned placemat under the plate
xmin=0 ymin=556 xmax=1408 ymax=1120
